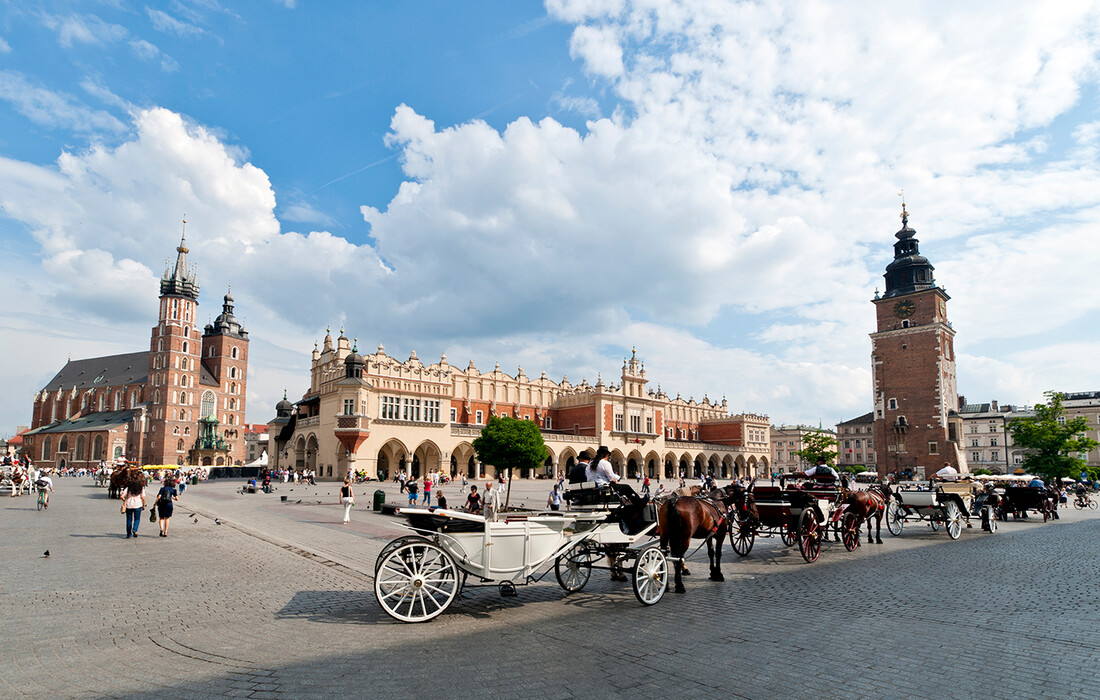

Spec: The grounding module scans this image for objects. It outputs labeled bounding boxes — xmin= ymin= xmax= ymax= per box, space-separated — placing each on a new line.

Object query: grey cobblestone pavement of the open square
xmin=0 ymin=479 xmax=1100 ymax=699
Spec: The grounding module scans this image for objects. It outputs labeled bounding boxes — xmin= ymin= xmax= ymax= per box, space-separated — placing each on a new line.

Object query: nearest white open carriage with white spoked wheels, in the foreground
xmin=374 ymin=483 xmax=670 ymax=622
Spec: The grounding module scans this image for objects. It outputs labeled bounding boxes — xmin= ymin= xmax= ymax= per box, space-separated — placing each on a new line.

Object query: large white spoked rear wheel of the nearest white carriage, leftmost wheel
xmin=374 ymin=542 xmax=460 ymax=622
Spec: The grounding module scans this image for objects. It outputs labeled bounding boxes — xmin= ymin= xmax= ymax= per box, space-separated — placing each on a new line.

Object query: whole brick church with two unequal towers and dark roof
xmin=24 ymin=232 xmax=249 ymax=468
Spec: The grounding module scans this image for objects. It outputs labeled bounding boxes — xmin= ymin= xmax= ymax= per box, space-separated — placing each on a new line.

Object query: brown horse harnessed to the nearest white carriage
xmin=657 ymin=486 xmax=733 ymax=593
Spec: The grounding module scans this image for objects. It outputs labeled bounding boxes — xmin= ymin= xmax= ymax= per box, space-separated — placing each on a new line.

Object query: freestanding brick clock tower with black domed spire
xmin=871 ymin=203 xmax=967 ymax=478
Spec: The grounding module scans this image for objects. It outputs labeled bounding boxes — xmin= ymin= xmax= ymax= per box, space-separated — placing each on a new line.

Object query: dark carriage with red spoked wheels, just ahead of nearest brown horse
xmin=729 ymin=479 xmax=859 ymax=564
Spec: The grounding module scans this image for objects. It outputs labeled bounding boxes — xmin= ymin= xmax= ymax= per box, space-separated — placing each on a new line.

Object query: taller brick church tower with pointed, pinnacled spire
xmin=146 ymin=221 xmax=201 ymax=464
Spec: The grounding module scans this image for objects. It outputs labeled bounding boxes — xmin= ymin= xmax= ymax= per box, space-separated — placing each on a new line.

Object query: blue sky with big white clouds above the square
xmin=0 ymin=0 xmax=1100 ymax=436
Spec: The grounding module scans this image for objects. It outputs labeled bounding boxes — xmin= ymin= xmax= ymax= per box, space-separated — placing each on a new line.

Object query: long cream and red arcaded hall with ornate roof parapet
xmin=268 ymin=331 xmax=771 ymax=480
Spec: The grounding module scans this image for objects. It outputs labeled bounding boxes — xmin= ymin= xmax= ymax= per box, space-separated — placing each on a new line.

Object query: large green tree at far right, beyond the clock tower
xmin=1009 ymin=392 xmax=1097 ymax=480
